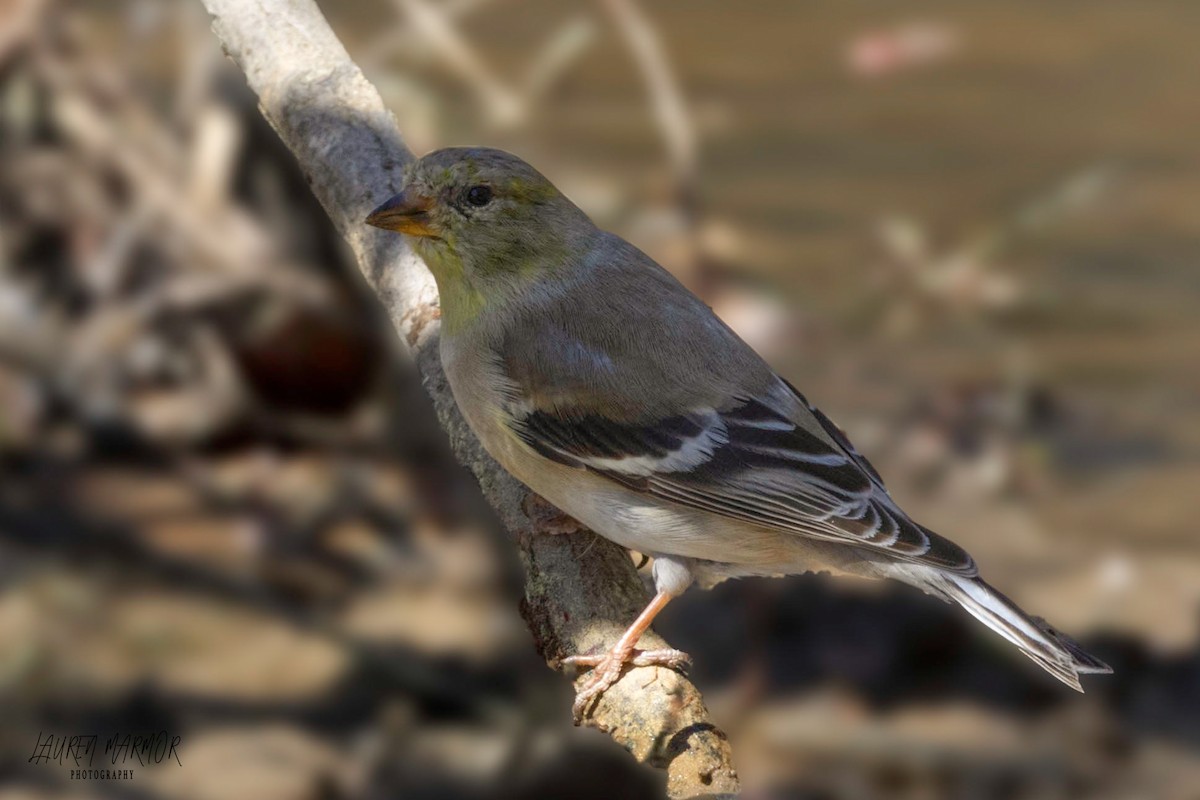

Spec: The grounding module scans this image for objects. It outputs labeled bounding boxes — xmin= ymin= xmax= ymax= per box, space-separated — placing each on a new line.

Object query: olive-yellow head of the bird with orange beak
xmin=366 ymin=148 xmax=595 ymax=326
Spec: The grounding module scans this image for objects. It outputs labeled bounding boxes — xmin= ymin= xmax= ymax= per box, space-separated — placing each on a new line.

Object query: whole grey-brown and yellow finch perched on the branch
xmin=366 ymin=148 xmax=1111 ymax=723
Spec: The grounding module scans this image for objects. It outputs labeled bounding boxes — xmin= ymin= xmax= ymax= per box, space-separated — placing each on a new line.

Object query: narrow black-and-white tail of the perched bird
xmin=923 ymin=570 xmax=1112 ymax=692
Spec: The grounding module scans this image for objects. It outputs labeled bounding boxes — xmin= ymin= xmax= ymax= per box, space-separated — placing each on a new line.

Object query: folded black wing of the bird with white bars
xmin=512 ymin=386 xmax=976 ymax=575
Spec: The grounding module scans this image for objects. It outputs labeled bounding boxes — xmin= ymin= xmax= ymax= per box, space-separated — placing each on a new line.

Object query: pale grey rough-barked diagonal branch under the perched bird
xmin=204 ymin=0 xmax=738 ymax=798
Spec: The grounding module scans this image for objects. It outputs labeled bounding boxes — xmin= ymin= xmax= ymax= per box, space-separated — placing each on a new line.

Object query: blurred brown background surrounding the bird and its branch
xmin=0 ymin=0 xmax=1200 ymax=800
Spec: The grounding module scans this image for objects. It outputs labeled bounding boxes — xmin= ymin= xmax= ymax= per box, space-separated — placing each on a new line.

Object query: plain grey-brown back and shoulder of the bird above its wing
xmin=496 ymin=234 xmax=775 ymax=421
